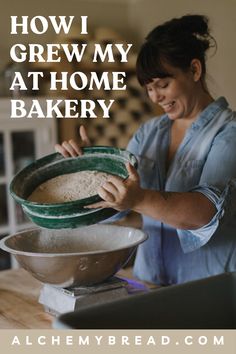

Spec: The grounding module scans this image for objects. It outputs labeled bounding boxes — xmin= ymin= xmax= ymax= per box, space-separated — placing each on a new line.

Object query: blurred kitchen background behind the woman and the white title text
xmin=0 ymin=0 xmax=236 ymax=269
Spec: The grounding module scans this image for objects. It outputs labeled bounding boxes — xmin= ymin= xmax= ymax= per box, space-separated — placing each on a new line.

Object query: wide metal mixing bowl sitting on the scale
xmin=0 ymin=225 xmax=147 ymax=287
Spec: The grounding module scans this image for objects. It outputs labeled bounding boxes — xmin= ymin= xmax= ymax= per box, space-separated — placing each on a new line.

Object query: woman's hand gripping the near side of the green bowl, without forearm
xmin=87 ymin=163 xmax=142 ymax=211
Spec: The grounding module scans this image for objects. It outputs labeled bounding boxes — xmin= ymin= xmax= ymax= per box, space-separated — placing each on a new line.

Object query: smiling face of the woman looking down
xmin=146 ymin=67 xmax=199 ymax=120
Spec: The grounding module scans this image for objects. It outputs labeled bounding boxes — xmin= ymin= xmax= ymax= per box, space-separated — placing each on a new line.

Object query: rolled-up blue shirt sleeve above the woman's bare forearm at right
xmin=177 ymin=120 xmax=236 ymax=253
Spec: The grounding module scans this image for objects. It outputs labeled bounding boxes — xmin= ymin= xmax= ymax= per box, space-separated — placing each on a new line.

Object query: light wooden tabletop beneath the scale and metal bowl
xmin=0 ymin=268 xmax=155 ymax=329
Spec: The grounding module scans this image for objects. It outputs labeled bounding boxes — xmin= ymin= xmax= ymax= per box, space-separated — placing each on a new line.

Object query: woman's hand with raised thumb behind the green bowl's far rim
xmin=55 ymin=125 xmax=91 ymax=157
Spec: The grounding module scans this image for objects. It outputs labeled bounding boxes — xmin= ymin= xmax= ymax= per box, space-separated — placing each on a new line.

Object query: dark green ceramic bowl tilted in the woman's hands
xmin=10 ymin=146 xmax=137 ymax=229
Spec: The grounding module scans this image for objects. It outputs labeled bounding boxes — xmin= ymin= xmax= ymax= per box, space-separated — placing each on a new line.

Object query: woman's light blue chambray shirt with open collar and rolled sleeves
xmin=127 ymin=97 xmax=236 ymax=285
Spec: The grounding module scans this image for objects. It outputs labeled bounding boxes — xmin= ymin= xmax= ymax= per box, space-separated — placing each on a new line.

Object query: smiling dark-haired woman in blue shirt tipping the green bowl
xmin=56 ymin=15 xmax=236 ymax=285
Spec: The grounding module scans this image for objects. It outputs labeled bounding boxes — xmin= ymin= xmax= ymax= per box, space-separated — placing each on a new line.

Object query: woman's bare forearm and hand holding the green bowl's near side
xmin=86 ymin=164 xmax=216 ymax=230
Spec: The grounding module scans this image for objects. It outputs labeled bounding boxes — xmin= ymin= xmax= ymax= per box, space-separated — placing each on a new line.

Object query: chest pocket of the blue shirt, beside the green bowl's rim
xmin=137 ymin=155 xmax=158 ymax=189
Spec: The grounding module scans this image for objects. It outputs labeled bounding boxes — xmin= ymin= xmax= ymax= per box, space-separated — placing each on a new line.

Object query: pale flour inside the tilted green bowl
xmin=28 ymin=171 xmax=111 ymax=204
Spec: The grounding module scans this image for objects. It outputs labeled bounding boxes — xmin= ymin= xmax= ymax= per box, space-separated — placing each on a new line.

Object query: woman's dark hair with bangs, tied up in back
xmin=136 ymin=15 xmax=216 ymax=86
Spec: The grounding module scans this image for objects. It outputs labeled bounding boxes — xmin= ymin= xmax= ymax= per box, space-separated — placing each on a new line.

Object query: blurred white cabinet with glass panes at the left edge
xmin=0 ymin=97 xmax=56 ymax=269
